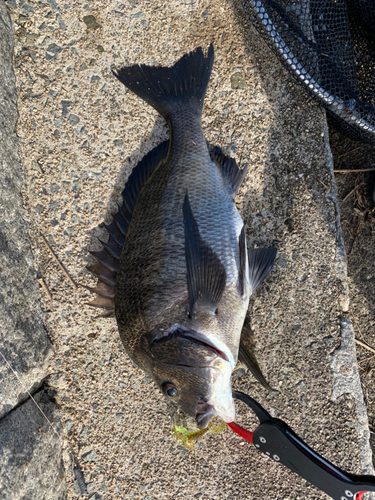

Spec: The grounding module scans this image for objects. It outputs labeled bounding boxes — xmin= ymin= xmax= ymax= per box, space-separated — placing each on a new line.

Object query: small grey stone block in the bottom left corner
xmin=0 ymin=391 xmax=66 ymax=500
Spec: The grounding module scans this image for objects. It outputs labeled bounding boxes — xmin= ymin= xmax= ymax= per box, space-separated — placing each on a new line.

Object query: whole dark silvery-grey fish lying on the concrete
xmin=88 ymin=44 xmax=277 ymax=429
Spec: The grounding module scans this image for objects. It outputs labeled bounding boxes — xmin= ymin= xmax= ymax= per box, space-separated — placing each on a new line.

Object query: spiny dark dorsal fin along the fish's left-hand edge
xmin=87 ymin=141 xmax=169 ymax=317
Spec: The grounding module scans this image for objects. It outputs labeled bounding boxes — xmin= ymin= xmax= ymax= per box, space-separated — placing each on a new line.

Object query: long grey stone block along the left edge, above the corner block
xmin=0 ymin=2 xmax=52 ymax=418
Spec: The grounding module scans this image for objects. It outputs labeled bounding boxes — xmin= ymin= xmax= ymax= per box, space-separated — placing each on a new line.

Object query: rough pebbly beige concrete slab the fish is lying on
xmin=6 ymin=0 xmax=370 ymax=500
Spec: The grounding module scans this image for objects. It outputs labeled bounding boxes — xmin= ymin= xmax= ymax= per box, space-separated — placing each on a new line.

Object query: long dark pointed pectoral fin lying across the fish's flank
xmin=183 ymin=194 xmax=226 ymax=315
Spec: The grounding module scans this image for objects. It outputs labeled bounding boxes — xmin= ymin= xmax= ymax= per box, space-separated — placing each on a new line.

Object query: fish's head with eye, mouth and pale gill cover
xmin=148 ymin=325 xmax=235 ymax=429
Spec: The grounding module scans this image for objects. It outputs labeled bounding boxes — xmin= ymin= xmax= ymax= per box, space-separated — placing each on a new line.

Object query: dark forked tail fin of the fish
xmin=112 ymin=44 xmax=214 ymax=119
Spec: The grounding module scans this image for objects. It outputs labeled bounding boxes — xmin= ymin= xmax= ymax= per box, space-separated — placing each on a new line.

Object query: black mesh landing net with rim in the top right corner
xmin=243 ymin=0 xmax=375 ymax=144
